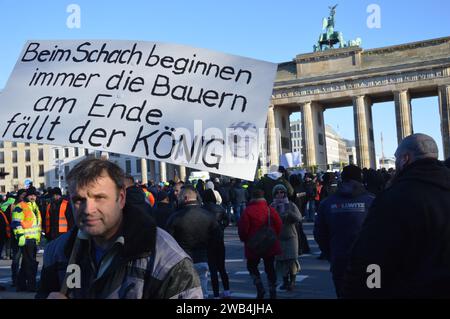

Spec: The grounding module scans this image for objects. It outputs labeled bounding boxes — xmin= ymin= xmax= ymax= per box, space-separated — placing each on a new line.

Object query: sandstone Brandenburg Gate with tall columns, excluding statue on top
xmin=267 ymin=37 xmax=450 ymax=168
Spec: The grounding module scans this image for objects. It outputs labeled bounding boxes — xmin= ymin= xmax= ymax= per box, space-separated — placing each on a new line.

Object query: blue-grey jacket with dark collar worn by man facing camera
xmin=36 ymin=202 xmax=202 ymax=299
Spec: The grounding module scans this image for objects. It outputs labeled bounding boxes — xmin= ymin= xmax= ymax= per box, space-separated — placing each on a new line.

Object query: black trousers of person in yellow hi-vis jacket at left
xmin=17 ymin=239 xmax=38 ymax=291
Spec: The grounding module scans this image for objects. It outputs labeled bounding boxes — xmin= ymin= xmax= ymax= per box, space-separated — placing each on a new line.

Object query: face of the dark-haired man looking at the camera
xmin=70 ymin=174 xmax=125 ymax=239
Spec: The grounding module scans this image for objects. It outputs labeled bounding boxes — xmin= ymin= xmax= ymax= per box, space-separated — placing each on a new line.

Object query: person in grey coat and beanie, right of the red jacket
xmin=271 ymin=184 xmax=302 ymax=291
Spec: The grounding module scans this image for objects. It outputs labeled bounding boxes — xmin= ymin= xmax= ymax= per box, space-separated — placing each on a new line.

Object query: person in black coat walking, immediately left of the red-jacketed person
xmin=203 ymin=189 xmax=230 ymax=299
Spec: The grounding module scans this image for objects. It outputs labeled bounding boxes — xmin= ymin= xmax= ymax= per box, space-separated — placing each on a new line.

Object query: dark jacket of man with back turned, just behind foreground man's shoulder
xmin=167 ymin=202 xmax=221 ymax=264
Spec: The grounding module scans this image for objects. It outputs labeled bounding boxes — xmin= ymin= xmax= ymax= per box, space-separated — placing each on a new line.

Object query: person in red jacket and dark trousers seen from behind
xmin=238 ymin=188 xmax=282 ymax=299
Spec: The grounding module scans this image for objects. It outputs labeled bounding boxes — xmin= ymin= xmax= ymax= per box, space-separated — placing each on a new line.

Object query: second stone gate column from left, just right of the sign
xmin=301 ymin=102 xmax=316 ymax=167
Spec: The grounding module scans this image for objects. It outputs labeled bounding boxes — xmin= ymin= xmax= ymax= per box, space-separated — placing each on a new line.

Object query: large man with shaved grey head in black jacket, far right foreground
xmin=344 ymin=134 xmax=450 ymax=298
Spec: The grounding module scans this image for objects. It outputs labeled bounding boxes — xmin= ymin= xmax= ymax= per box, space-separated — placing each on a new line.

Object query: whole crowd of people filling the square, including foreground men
xmin=0 ymin=134 xmax=450 ymax=298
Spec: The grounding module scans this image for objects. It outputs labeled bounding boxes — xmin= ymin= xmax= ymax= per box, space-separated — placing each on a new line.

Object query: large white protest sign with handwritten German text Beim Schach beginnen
xmin=0 ymin=40 xmax=277 ymax=180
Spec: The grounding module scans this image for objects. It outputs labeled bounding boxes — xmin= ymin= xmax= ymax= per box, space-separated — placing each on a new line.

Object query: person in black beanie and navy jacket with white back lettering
xmin=314 ymin=165 xmax=375 ymax=298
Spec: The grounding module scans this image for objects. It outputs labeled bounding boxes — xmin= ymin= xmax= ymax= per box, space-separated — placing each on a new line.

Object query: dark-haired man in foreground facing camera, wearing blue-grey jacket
xmin=36 ymin=158 xmax=202 ymax=299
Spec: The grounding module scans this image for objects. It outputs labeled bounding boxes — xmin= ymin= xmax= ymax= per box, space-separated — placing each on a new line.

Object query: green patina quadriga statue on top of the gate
xmin=313 ymin=4 xmax=361 ymax=52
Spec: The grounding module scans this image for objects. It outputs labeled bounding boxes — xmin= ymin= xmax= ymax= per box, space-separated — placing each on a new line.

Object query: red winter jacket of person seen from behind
xmin=238 ymin=199 xmax=283 ymax=259
